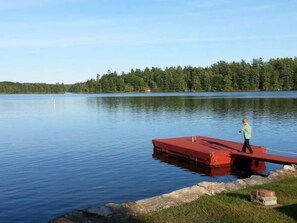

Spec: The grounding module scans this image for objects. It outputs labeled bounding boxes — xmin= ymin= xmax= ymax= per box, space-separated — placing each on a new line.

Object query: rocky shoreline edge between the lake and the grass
xmin=50 ymin=165 xmax=297 ymax=223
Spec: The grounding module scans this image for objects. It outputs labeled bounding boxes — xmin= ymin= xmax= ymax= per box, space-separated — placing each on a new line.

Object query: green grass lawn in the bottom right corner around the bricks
xmin=125 ymin=178 xmax=297 ymax=223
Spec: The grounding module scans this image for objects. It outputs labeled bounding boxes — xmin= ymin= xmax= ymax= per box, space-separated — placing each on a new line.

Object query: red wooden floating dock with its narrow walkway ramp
xmin=152 ymin=136 xmax=297 ymax=166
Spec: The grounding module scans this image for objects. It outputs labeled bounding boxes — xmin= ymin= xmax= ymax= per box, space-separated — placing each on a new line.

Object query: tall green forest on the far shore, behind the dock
xmin=68 ymin=57 xmax=297 ymax=93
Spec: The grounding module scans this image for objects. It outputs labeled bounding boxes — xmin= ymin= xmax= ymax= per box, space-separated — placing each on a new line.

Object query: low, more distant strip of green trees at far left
xmin=0 ymin=81 xmax=66 ymax=94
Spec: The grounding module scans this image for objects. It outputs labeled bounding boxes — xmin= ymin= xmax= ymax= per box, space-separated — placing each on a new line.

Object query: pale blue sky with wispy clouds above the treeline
xmin=0 ymin=0 xmax=297 ymax=83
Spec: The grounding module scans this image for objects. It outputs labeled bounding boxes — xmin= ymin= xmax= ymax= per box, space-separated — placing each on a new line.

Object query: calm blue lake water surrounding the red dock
xmin=0 ymin=92 xmax=297 ymax=223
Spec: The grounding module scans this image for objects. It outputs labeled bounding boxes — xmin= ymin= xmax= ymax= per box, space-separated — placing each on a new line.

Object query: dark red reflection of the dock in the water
xmin=153 ymin=151 xmax=266 ymax=177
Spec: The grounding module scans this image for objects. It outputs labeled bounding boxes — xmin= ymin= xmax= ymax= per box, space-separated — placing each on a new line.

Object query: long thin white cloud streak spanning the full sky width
xmin=0 ymin=34 xmax=297 ymax=49
